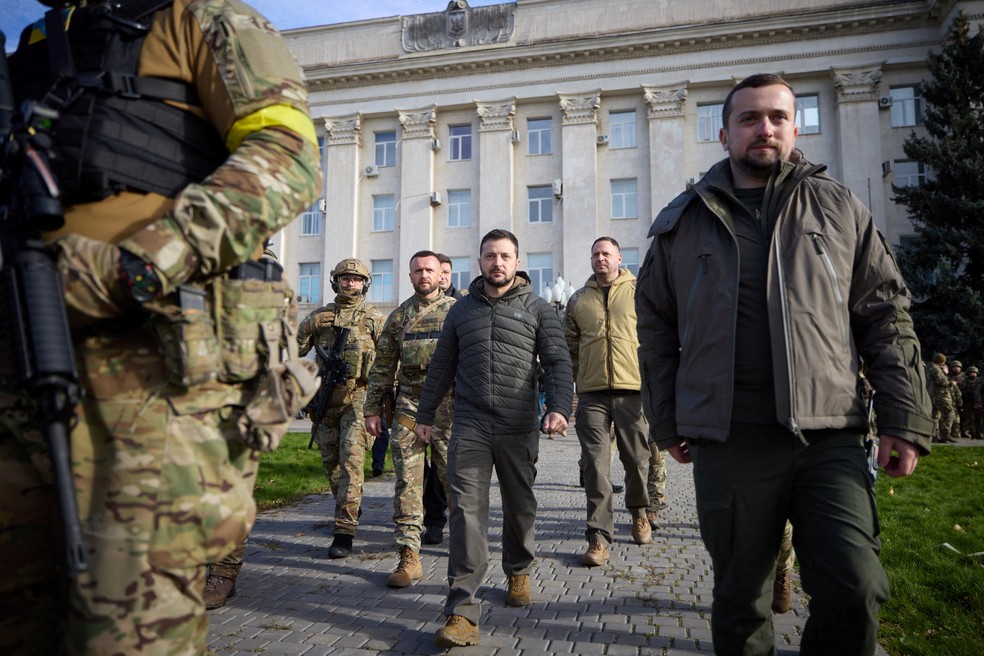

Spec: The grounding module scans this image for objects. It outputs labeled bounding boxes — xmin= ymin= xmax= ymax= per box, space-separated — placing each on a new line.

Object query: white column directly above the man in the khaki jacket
xmin=554 ymin=89 xmax=601 ymax=289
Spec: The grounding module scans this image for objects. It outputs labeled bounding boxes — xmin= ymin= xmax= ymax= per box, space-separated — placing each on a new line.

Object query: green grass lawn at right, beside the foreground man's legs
xmin=877 ymin=445 xmax=984 ymax=656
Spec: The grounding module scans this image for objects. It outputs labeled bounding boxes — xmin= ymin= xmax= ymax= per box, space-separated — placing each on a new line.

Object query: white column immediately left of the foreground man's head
xmin=640 ymin=82 xmax=691 ymax=218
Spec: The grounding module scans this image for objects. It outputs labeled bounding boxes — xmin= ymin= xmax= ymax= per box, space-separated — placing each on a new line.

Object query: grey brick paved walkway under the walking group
xmin=209 ymin=426 xmax=884 ymax=656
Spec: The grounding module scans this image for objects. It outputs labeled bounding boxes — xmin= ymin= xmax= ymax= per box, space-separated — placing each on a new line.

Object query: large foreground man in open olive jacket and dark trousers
xmin=636 ymin=75 xmax=933 ymax=655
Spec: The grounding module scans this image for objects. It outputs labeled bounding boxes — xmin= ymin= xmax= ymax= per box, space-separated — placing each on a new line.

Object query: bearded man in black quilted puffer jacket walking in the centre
xmin=416 ymin=230 xmax=574 ymax=648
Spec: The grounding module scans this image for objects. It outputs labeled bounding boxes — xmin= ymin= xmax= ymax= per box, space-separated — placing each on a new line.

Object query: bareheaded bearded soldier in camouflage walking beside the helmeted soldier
xmin=365 ymin=251 xmax=455 ymax=588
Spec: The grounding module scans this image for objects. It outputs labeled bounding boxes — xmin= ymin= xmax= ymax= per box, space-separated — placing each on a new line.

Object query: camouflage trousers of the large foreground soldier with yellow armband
xmin=0 ymin=340 xmax=258 ymax=655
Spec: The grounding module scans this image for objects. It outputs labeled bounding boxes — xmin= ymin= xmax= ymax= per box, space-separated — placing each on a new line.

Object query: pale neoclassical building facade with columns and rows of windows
xmin=274 ymin=0 xmax=984 ymax=311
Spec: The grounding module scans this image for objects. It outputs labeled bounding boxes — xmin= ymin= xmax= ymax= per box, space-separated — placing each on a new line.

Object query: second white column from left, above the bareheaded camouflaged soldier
xmin=393 ymin=107 xmax=437 ymax=303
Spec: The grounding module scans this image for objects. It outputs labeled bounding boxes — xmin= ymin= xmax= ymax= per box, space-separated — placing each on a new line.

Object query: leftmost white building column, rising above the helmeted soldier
xmin=321 ymin=114 xmax=368 ymax=300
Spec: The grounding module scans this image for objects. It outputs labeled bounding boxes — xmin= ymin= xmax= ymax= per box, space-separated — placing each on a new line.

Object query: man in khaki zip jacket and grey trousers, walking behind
xmin=564 ymin=237 xmax=652 ymax=567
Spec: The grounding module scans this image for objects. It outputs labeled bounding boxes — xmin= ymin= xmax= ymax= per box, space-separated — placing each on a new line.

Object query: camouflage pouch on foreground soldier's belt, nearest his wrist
xmin=144 ymin=285 xmax=219 ymax=388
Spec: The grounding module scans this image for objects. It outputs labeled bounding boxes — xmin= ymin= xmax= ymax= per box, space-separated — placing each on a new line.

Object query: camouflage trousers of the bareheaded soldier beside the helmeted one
xmin=390 ymin=394 xmax=451 ymax=553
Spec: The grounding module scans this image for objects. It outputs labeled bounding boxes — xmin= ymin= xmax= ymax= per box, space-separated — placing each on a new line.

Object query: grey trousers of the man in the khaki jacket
xmin=576 ymin=392 xmax=652 ymax=543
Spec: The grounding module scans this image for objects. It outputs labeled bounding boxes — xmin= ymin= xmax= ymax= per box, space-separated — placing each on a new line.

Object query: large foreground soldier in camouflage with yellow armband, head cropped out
xmin=0 ymin=0 xmax=321 ymax=655
